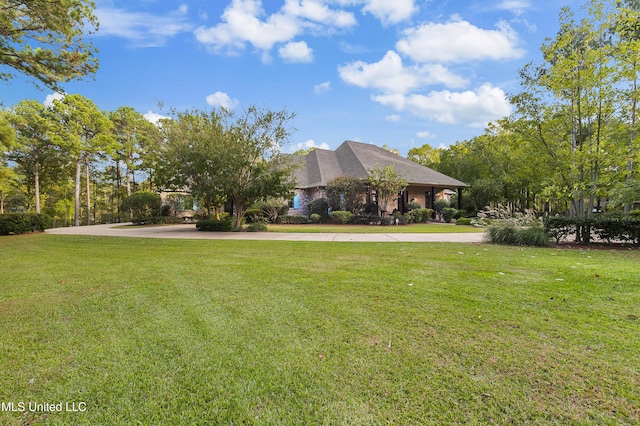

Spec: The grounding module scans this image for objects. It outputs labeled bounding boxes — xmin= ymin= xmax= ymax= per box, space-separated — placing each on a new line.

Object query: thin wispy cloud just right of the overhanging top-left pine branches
xmin=96 ymin=4 xmax=192 ymax=47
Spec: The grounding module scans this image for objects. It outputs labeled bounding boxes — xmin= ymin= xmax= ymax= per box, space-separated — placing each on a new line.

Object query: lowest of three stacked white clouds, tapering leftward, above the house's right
xmin=372 ymin=84 xmax=512 ymax=127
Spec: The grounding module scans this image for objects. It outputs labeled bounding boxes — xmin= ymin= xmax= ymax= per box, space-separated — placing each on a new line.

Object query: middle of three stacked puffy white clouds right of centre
xmin=338 ymin=50 xmax=468 ymax=93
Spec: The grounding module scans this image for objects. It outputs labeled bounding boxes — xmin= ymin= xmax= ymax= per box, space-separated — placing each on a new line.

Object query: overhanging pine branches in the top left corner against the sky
xmin=0 ymin=0 xmax=98 ymax=92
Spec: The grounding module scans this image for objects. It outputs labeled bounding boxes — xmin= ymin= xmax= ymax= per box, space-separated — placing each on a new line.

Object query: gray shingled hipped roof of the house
xmin=292 ymin=141 xmax=467 ymax=188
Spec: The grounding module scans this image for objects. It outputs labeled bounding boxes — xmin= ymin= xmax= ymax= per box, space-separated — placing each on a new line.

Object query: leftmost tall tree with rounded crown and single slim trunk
xmin=7 ymin=100 xmax=59 ymax=213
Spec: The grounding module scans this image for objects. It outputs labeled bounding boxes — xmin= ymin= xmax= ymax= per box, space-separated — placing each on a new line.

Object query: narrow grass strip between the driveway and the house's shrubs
xmin=267 ymin=223 xmax=484 ymax=234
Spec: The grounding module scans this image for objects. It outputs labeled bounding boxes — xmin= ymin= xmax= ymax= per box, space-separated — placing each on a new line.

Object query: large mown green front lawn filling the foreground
xmin=0 ymin=235 xmax=640 ymax=425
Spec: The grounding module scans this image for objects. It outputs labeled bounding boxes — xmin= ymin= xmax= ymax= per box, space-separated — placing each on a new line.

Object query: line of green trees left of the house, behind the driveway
xmin=0 ymin=98 xmax=294 ymax=226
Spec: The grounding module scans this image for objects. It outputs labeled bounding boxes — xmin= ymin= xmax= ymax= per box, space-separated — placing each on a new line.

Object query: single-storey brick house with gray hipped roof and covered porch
xmin=290 ymin=141 xmax=467 ymax=215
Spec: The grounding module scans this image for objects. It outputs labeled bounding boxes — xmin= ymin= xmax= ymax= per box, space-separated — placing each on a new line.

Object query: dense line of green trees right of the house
xmin=408 ymin=0 xmax=640 ymax=218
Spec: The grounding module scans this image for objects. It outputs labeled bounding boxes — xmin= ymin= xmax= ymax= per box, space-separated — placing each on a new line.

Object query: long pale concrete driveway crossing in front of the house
xmin=45 ymin=224 xmax=483 ymax=243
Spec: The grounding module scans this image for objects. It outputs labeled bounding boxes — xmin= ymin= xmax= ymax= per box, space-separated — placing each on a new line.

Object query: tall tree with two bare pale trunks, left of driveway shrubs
xmin=52 ymin=95 xmax=113 ymax=226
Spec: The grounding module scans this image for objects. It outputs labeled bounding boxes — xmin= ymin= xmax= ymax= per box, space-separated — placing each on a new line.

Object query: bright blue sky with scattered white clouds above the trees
xmin=0 ymin=0 xmax=577 ymax=155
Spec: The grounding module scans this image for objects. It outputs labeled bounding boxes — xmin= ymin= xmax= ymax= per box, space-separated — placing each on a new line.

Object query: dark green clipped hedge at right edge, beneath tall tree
xmin=544 ymin=216 xmax=640 ymax=244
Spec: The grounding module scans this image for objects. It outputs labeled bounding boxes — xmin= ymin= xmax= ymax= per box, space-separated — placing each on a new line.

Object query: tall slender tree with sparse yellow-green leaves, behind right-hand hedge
xmin=512 ymin=0 xmax=614 ymax=223
